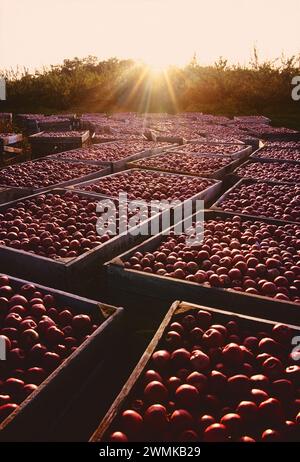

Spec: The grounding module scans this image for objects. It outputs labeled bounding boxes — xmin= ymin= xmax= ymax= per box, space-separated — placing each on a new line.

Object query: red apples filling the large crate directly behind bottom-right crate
xmin=124 ymin=216 xmax=300 ymax=303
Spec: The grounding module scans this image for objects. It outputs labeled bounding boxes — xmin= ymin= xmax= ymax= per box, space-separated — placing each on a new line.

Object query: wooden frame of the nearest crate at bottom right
xmin=90 ymin=301 xmax=300 ymax=443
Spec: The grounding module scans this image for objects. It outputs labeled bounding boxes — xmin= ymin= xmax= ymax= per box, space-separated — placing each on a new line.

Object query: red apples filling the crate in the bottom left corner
xmin=0 ymin=275 xmax=99 ymax=422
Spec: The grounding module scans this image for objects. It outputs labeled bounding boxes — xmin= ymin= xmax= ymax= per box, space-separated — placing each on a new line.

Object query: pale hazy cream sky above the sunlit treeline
xmin=0 ymin=0 xmax=300 ymax=68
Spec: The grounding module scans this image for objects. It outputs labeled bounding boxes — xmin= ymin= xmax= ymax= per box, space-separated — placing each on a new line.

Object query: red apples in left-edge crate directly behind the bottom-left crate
xmin=0 ymin=192 xmax=149 ymax=260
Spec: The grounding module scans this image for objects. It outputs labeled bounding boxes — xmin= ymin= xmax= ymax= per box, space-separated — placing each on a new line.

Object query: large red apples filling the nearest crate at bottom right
xmin=103 ymin=306 xmax=300 ymax=442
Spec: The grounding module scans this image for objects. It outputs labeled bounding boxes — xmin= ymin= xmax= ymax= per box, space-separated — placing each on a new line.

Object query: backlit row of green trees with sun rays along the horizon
xmin=0 ymin=49 xmax=300 ymax=125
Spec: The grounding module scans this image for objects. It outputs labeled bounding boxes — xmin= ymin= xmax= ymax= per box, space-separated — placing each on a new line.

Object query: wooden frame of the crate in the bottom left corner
xmin=0 ymin=278 xmax=123 ymax=442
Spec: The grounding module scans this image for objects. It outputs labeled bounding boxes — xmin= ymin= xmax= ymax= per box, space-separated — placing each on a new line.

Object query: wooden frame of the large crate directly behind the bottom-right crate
xmin=104 ymin=210 xmax=300 ymax=325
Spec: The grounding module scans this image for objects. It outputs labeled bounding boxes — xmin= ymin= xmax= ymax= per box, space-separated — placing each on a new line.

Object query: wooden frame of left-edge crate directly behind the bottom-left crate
xmin=0 ymin=189 xmax=166 ymax=295
